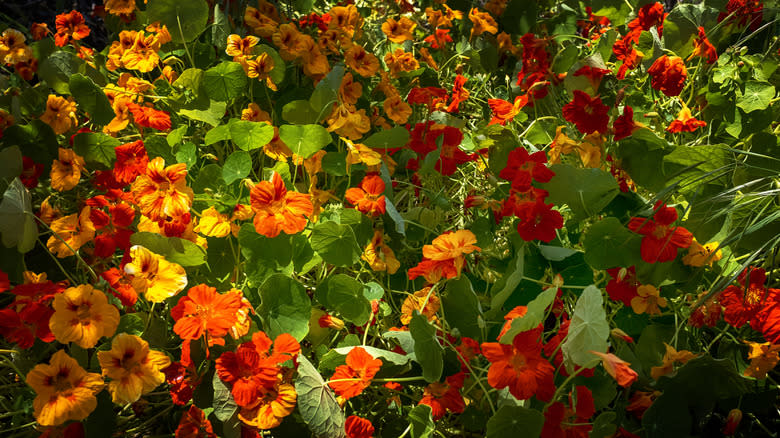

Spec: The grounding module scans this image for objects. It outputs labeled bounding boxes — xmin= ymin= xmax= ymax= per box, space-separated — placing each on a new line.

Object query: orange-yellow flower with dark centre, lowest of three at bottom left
xmin=25 ymin=350 xmax=105 ymax=426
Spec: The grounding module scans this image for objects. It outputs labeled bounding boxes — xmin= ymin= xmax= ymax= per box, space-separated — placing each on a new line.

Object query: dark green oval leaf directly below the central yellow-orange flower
xmin=441 ymin=275 xmax=484 ymax=341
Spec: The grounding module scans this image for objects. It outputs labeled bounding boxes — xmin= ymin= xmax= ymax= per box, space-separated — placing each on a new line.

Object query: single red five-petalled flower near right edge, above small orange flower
xmin=628 ymin=200 xmax=693 ymax=263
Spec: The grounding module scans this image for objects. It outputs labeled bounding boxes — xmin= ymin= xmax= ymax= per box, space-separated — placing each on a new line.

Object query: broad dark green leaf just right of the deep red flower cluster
xmin=541 ymin=164 xmax=620 ymax=219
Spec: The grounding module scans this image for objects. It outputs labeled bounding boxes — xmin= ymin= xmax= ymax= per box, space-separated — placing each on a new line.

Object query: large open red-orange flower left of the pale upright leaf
xmin=482 ymin=328 xmax=555 ymax=401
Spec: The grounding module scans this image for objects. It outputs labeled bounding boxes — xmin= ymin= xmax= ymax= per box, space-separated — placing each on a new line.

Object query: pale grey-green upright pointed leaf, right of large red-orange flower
xmin=561 ymin=285 xmax=609 ymax=368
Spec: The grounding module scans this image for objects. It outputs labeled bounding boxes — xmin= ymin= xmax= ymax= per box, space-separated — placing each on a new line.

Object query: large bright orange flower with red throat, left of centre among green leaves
xmin=249 ymin=172 xmax=314 ymax=238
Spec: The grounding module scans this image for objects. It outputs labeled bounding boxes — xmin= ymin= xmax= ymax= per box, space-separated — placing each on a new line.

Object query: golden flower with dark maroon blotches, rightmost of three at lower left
xmin=98 ymin=333 xmax=171 ymax=405
